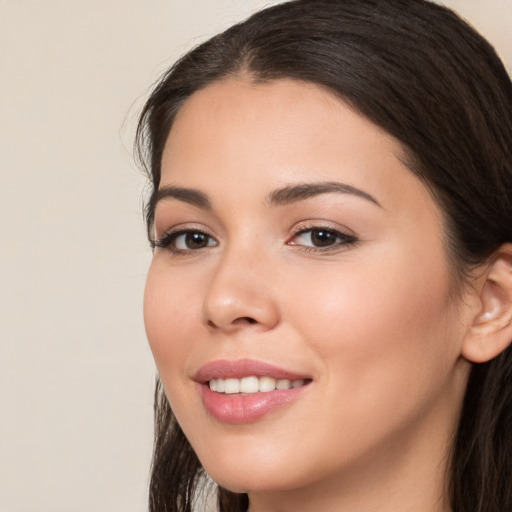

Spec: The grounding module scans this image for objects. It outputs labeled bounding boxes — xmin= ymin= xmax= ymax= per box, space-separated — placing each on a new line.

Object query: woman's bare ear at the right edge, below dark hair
xmin=462 ymin=244 xmax=512 ymax=363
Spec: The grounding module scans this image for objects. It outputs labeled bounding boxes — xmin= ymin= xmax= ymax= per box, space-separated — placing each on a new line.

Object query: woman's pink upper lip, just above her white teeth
xmin=193 ymin=359 xmax=311 ymax=384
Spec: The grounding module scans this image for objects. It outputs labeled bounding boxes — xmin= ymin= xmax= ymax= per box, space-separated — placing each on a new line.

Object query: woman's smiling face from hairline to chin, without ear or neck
xmin=145 ymin=79 xmax=472 ymax=500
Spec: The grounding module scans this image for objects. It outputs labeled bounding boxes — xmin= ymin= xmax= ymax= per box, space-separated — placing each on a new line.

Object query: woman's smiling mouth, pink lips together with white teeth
xmin=194 ymin=359 xmax=313 ymax=424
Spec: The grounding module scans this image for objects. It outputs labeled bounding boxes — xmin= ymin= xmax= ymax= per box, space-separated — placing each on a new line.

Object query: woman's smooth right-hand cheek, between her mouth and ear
xmin=291 ymin=242 xmax=458 ymax=414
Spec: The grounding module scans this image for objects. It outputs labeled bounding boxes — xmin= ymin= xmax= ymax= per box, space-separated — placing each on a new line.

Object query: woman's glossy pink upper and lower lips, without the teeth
xmin=194 ymin=359 xmax=311 ymax=424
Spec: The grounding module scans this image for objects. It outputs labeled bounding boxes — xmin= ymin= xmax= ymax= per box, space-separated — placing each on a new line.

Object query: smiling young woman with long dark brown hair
xmin=139 ymin=0 xmax=512 ymax=512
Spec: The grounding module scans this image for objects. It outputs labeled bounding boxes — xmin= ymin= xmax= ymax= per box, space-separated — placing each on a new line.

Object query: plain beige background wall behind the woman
xmin=0 ymin=0 xmax=512 ymax=512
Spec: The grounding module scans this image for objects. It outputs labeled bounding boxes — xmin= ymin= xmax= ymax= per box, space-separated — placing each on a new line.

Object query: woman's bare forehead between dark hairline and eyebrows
xmin=161 ymin=78 xmax=426 ymax=216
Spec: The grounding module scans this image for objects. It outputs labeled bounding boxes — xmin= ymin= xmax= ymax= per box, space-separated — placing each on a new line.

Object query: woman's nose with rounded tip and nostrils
xmin=203 ymin=248 xmax=280 ymax=333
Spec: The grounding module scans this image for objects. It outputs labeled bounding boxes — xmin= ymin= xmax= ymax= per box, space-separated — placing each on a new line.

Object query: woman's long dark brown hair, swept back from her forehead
xmin=137 ymin=0 xmax=512 ymax=512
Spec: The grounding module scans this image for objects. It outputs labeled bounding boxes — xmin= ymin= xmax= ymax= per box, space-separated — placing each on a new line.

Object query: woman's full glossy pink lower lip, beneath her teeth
xmin=201 ymin=384 xmax=309 ymax=424
